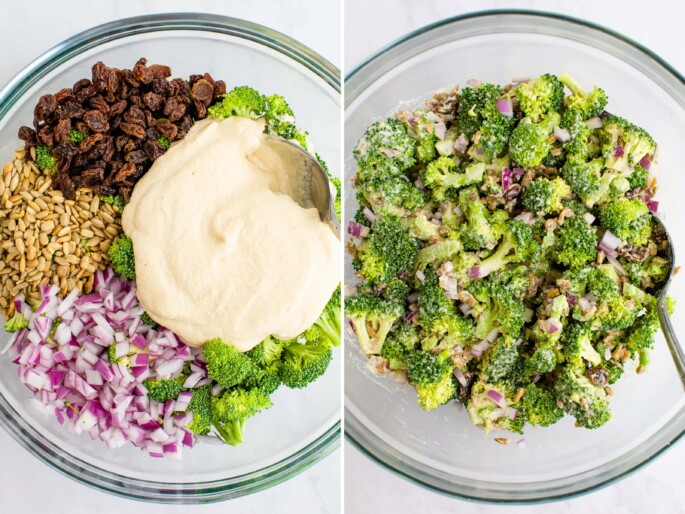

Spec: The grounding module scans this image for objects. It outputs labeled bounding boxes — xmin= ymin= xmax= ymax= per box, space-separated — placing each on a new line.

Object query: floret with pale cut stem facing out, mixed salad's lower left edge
xmin=345 ymin=295 xmax=404 ymax=355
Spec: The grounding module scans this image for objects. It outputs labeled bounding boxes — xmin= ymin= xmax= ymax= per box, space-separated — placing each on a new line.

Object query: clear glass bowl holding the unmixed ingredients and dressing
xmin=0 ymin=14 xmax=341 ymax=503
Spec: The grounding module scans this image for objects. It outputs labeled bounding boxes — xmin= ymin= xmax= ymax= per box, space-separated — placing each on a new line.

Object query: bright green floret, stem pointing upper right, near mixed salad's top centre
xmin=509 ymin=112 xmax=561 ymax=168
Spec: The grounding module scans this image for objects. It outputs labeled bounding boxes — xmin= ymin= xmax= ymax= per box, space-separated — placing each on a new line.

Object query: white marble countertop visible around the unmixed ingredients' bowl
xmin=0 ymin=0 xmax=342 ymax=514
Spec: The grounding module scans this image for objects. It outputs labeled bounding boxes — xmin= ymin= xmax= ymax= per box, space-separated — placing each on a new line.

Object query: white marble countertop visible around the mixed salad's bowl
xmin=344 ymin=0 xmax=685 ymax=514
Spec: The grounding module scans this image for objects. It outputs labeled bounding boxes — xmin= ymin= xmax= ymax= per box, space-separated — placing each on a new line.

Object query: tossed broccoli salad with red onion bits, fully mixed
xmin=345 ymin=74 xmax=672 ymax=433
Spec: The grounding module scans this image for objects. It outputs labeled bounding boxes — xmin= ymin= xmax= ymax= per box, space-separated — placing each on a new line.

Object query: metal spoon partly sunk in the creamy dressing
xmin=264 ymin=134 xmax=340 ymax=235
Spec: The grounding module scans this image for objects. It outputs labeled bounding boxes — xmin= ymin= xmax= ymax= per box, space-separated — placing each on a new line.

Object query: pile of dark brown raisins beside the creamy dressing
xmin=19 ymin=58 xmax=226 ymax=202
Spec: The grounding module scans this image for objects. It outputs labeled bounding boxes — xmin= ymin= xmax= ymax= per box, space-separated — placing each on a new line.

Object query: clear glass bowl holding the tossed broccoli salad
xmin=345 ymin=11 xmax=685 ymax=502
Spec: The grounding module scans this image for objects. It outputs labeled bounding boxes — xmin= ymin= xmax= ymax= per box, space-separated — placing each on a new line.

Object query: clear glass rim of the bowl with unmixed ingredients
xmin=0 ymin=13 xmax=341 ymax=504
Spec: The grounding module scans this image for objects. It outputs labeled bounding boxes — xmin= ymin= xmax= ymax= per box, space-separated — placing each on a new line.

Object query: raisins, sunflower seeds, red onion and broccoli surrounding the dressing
xmin=0 ymin=59 xmax=341 ymax=457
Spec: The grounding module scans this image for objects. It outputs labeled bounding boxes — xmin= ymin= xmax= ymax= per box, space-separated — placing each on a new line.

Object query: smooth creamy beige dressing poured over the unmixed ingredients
xmin=122 ymin=117 xmax=341 ymax=351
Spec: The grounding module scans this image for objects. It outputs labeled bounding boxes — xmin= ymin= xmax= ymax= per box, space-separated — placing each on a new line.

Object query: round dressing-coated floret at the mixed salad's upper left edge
xmin=353 ymin=119 xmax=416 ymax=179
